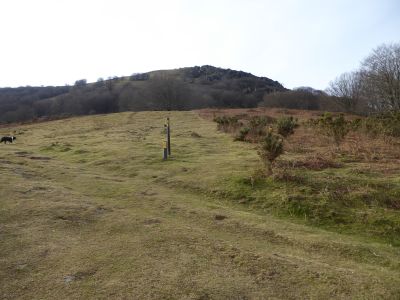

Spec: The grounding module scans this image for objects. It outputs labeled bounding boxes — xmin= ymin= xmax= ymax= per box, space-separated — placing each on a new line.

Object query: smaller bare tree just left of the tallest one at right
xmin=326 ymin=72 xmax=363 ymax=112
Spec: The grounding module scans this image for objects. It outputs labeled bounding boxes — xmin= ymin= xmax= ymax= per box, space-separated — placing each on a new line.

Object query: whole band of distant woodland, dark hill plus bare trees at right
xmin=0 ymin=44 xmax=400 ymax=123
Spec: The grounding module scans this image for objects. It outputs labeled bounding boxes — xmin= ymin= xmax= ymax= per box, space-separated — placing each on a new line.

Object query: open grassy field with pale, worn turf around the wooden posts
xmin=0 ymin=111 xmax=400 ymax=299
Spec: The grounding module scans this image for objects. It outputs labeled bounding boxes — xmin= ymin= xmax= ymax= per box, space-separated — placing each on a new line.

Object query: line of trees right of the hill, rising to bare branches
xmin=260 ymin=43 xmax=400 ymax=115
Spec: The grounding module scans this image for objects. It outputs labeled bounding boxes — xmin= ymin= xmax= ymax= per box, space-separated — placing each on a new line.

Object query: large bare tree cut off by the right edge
xmin=361 ymin=43 xmax=400 ymax=110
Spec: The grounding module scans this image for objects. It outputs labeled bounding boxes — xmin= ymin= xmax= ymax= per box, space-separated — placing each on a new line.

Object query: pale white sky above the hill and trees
xmin=0 ymin=0 xmax=400 ymax=89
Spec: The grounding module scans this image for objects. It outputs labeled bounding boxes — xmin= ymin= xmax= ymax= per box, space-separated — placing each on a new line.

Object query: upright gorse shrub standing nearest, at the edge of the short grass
xmin=258 ymin=132 xmax=283 ymax=175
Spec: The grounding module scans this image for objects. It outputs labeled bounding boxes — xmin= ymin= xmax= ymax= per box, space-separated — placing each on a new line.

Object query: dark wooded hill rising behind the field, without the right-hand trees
xmin=0 ymin=66 xmax=286 ymax=123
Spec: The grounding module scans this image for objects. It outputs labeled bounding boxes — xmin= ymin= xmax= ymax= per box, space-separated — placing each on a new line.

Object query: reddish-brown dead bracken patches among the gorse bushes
xmin=197 ymin=107 xmax=400 ymax=174
